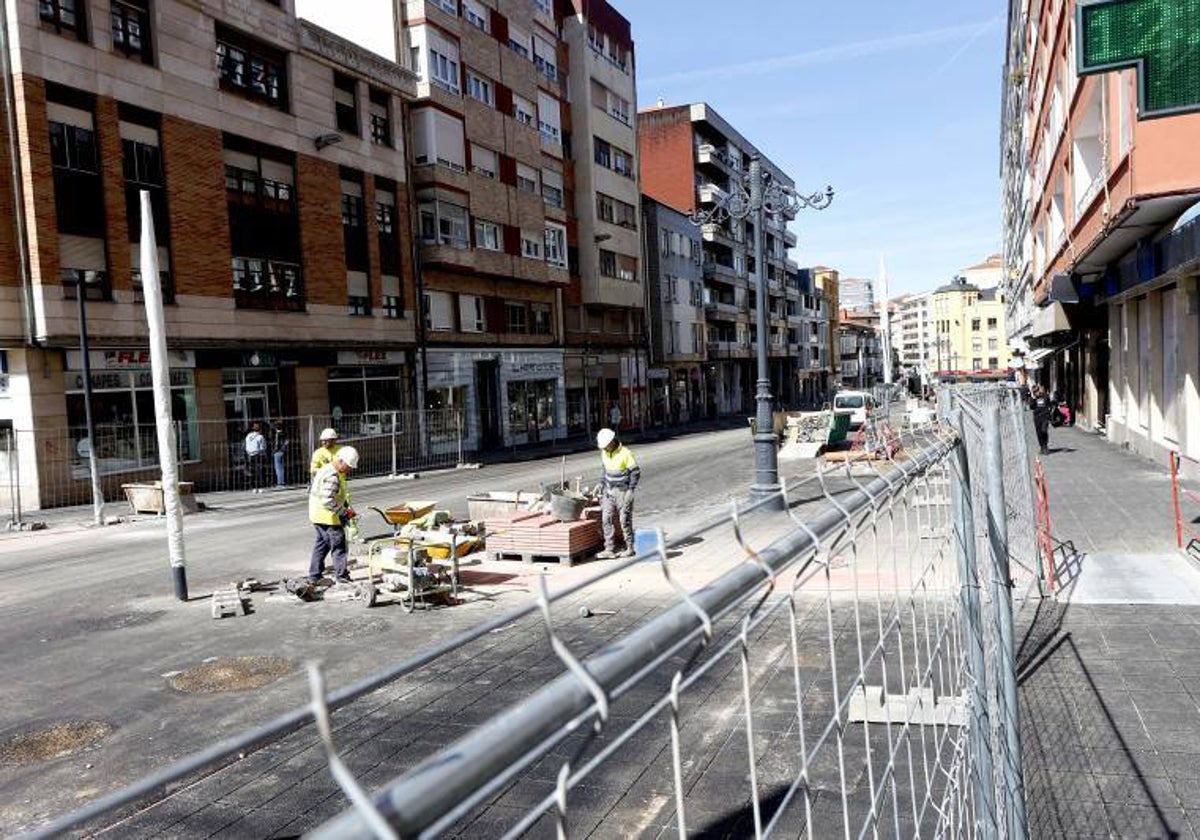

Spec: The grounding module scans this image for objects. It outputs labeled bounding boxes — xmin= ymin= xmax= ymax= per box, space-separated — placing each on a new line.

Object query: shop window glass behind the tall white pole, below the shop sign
xmin=66 ymin=370 xmax=199 ymax=479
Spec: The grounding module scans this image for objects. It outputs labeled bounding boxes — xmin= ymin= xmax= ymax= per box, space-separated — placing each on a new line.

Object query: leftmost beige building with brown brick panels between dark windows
xmin=0 ymin=0 xmax=416 ymax=508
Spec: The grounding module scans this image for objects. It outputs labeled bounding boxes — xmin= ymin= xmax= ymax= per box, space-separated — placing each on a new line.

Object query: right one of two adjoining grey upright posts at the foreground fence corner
xmin=983 ymin=402 xmax=1026 ymax=840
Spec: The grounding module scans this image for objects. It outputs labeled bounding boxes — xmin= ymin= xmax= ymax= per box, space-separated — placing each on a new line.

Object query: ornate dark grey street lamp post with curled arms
xmin=691 ymin=155 xmax=833 ymax=508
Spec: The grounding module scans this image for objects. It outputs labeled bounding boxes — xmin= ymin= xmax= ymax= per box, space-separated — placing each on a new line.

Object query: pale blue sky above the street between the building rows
xmin=296 ymin=0 xmax=1007 ymax=296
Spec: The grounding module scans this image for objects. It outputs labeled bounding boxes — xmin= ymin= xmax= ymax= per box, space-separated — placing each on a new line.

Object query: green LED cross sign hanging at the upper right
xmin=1075 ymin=0 xmax=1200 ymax=119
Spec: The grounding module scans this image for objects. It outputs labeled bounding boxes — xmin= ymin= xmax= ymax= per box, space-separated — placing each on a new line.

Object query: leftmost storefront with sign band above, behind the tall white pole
xmin=65 ymin=350 xmax=200 ymax=479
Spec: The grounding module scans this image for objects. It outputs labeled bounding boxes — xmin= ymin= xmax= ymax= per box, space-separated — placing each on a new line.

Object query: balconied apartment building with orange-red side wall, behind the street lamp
xmin=637 ymin=102 xmax=800 ymax=414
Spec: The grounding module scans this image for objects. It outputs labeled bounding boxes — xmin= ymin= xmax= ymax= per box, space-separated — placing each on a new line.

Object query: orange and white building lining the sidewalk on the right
xmin=1001 ymin=0 xmax=1200 ymax=472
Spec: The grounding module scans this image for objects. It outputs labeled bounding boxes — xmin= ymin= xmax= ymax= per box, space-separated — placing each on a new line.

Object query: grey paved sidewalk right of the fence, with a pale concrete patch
xmin=1016 ymin=428 xmax=1200 ymax=838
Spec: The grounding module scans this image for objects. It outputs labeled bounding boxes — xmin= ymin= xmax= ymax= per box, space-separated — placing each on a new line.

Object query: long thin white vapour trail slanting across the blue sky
xmin=640 ymin=18 xmax=998 ymax=85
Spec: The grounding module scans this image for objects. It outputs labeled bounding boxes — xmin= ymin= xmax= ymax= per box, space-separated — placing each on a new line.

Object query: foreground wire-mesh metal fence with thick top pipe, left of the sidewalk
xmin=25 ymin=396 xmax=1025 ymax=838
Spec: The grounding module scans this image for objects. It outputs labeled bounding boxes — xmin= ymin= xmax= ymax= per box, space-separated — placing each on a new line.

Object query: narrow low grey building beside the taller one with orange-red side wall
xmin=642 ymin=197 xmax=700 ymax=424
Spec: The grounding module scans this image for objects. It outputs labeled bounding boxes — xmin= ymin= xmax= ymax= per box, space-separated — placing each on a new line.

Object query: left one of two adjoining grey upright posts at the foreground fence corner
xmin=950 ymin=409 xmax=998 ymax=840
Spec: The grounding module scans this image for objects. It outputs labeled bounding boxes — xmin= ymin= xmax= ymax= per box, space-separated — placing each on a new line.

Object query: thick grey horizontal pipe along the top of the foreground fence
xmin=310 ymin=429 xmax=955 ymax=838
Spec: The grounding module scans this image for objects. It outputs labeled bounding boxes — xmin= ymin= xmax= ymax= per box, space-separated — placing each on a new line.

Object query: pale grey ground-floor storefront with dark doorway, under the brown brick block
xmin=425 ymin=349 xmax=566 ymax=451
